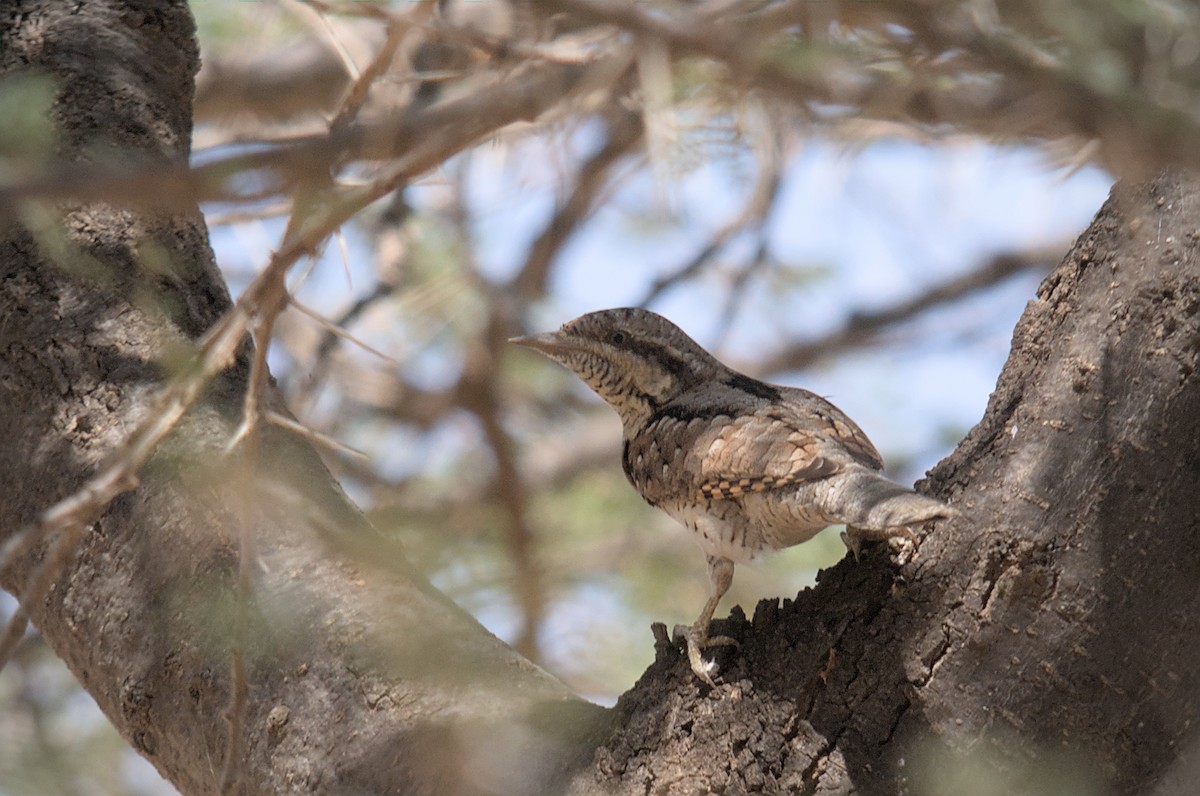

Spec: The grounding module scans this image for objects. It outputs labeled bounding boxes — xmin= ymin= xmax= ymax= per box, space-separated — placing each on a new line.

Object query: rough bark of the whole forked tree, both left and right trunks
xmin=0 ymin=0 xmax=1200 ymax=794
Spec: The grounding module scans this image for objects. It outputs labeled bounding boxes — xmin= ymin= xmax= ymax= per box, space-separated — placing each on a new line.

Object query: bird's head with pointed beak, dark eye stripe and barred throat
xmin=509 ymin=307 xmax=726 ymax=429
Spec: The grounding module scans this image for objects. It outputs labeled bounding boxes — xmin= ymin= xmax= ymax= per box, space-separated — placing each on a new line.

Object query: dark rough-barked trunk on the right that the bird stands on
xmin=573 ymin=176 xmax=1200 ymax=794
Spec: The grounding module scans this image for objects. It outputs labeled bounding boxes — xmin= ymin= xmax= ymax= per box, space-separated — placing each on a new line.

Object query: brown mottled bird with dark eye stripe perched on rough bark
xmin=509 ymin=307 xmax=958 ymax=686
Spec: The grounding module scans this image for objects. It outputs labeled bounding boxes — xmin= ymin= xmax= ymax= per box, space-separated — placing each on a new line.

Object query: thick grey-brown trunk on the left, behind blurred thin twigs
xmin=0 ymin=6 xmax=600 ymax=794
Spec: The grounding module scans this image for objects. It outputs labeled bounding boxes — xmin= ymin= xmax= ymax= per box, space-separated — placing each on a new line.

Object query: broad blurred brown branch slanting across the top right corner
xmin=542 ymin=0 xmax=1200 ymax=173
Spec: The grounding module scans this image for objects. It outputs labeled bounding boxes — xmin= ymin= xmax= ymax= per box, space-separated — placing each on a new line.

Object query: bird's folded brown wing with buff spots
xmin=697 ymin=390 xmax=883 ymax=499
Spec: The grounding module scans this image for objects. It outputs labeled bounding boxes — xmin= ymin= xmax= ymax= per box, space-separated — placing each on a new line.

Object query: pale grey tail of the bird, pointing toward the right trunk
xmin=829 ymin=467 xmax=958 ymax=535
